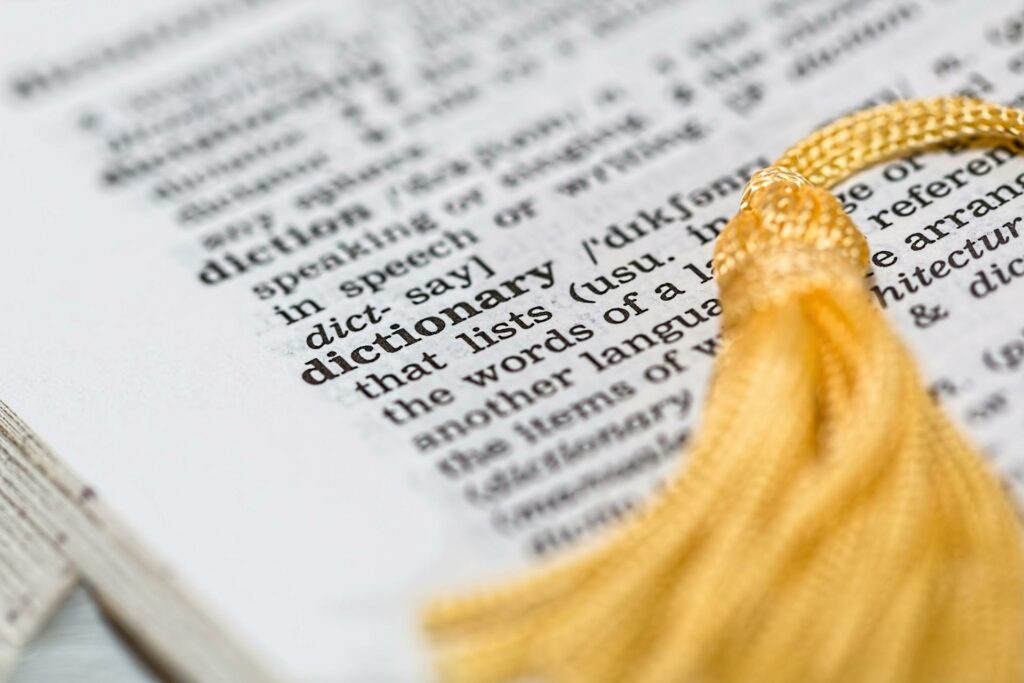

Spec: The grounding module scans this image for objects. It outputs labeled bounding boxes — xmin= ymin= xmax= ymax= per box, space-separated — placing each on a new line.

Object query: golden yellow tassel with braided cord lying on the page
xmin=426 ymin=98 xmax=1024 ymax=683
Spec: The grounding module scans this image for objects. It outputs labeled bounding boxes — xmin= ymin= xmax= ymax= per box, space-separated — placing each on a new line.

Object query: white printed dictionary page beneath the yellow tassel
xmin=6 ymin=0 xmax=1024 ymax=683
